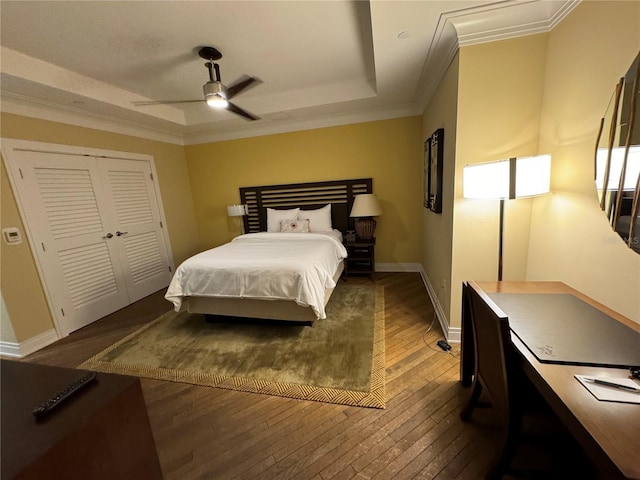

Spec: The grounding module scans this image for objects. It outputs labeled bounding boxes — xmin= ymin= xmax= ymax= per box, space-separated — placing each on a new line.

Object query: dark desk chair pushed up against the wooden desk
xmin=460 ymin=282 xmax=591 ymax=480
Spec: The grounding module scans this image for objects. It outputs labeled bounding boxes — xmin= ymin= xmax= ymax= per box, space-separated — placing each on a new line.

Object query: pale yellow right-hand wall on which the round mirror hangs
xmin=528 ymin=1 xmax=640 ymax=323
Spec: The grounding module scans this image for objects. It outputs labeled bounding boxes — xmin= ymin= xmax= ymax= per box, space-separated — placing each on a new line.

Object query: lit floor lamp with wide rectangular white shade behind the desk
xmin=462 ymin=155 xmax=551 ymax=281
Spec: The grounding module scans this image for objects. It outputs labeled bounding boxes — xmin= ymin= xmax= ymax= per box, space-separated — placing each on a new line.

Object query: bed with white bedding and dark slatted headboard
xmin=165 ymin=178 xmax=372 ymax=324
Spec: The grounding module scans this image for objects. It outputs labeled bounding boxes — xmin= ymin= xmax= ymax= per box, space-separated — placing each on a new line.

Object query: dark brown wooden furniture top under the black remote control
xmin=1 ymin=360 xmax=162 ymax=480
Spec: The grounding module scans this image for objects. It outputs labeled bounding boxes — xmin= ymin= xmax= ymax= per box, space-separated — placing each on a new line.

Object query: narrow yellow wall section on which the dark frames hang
xmin=422 ymin=55 xmax=459 ymax=326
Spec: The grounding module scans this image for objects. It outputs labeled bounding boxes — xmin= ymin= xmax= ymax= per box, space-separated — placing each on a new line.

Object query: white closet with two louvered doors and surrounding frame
xmin=2 ymin=139 xmax=172 ymax=337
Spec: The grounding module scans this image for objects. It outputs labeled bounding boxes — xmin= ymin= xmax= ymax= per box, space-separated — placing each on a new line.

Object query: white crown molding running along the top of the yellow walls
xmin=0 ymin=0 xmax=580 ymax=145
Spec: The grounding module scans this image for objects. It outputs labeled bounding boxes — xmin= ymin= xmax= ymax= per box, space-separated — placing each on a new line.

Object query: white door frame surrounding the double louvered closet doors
xmin=0 ymin=138 xmax=175 ymax=339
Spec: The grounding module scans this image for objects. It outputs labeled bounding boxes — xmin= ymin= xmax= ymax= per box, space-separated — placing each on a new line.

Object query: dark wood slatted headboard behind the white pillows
xmin=240 ymin=178 xmax=373 ymax=233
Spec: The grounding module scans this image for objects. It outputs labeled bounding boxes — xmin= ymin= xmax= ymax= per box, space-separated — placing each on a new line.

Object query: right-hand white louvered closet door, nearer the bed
xmin=99 ymin=159 xmax=171 ymax=302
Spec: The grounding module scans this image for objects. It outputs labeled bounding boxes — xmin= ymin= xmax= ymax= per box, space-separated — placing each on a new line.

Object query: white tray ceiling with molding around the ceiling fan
xmin=0 ymin=0 xmax=579 ymax=144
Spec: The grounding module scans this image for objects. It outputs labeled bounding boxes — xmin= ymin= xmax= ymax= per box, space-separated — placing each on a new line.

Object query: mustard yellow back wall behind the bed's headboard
xmin=186 ymin=117 xmax=422 ymax=263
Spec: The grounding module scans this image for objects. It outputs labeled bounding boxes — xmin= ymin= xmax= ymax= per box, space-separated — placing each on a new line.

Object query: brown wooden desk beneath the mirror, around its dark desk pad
xmin=460 ymin=282 xmax=640 ymax=479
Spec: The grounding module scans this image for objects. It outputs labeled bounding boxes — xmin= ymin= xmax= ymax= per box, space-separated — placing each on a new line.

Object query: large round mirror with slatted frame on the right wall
xmin=595 ymin=53 xmax=640 ymax=253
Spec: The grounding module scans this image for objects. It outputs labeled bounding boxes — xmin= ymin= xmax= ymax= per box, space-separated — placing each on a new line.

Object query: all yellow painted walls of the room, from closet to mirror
xmin=6 ymin=1 xmax=640 ymax=341
